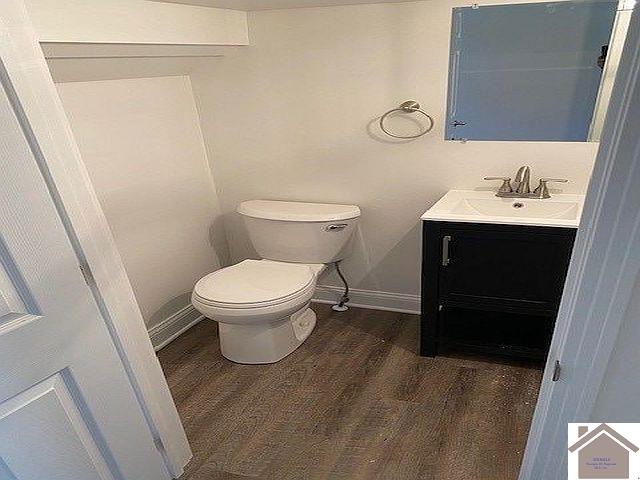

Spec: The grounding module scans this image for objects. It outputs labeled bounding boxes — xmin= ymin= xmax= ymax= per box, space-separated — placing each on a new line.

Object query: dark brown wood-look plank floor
xmin=160 ymin=305 xmax=541 ymax=480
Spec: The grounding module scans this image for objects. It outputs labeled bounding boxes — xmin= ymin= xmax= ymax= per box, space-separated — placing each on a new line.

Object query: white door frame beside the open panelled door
xmin=0 ymin=0 xmax=192 ymax=478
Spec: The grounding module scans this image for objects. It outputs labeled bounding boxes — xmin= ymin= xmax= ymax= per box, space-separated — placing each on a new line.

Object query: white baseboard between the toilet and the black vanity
xmin=312 ymin=285 xmax=420 ymax=314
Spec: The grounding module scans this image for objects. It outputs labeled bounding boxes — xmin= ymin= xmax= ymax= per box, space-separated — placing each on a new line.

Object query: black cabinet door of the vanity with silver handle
xmin=440 ymin=226 xmax=573 ymax=314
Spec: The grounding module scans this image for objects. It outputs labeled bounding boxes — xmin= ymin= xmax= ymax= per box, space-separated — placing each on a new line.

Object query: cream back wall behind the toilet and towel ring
xmin=192 ymin=0 xmax=597 ymax=295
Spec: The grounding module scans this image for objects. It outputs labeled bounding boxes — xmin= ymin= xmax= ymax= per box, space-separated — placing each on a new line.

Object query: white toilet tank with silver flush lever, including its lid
xmin=238 ymin=200 xmax=360 ymax=263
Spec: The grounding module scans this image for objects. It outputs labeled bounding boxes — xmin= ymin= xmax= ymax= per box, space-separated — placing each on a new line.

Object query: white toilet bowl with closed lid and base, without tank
xmin=191 ymin=260 xmax=325 ymax=364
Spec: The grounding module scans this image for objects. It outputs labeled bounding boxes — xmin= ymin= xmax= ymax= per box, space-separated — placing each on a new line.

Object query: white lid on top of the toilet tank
xmin=238 ymin=200 xmax=360 ymax=222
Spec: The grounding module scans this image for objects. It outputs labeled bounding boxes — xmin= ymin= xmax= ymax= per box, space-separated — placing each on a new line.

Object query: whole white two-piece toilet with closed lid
xmin=191 ymin=200 xmax=360 ymax=364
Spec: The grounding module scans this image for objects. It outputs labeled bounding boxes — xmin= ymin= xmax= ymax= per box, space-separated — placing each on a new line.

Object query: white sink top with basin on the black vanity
xmin=421 ymin=190 xmax=584 ymax=228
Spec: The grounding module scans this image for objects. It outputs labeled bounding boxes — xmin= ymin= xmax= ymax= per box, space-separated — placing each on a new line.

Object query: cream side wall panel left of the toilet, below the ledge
xmin=58 ymin=76 xmax=226 ymax=327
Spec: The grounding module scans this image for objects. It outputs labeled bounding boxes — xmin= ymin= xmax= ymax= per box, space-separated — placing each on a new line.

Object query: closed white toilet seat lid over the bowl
xmin=194 ymin=260 xmax=314 ymax=304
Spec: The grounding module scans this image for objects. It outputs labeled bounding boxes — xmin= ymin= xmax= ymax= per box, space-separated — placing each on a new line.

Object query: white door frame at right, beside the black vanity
xmin=519 ymin=7 xmax=640 ymax=480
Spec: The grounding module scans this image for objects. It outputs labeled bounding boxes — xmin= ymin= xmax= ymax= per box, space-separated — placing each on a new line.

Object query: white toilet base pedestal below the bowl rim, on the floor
xmin=218 ymin=304 xmax=316 ymax=365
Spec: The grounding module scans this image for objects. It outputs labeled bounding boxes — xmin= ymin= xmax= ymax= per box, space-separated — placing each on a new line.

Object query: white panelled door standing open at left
xmin=0 ymin=53 xmax=169 ymax=480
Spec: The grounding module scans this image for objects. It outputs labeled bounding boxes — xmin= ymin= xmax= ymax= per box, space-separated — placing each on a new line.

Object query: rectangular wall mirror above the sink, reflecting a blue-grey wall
xmin=445 ymin=0 xmax=635 ymax=142
